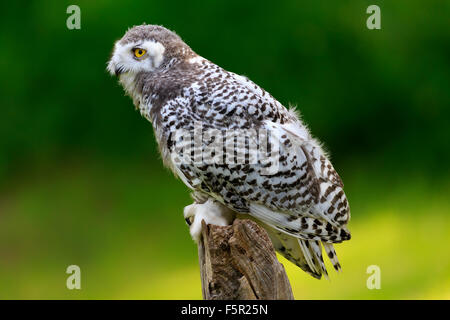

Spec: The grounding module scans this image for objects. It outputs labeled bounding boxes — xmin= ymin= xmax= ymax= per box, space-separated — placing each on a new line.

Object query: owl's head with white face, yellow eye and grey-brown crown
xmin=107 ymin=24 xmax=195 ymax=76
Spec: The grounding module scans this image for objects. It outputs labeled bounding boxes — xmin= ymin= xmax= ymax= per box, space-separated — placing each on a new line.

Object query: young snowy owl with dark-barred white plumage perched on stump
xmin=107 ymin=24 xmax=350 ymax=279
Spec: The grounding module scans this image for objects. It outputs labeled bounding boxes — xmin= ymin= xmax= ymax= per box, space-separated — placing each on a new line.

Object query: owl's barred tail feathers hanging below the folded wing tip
xmin=264 ymin=225 xmax=341 ymax=279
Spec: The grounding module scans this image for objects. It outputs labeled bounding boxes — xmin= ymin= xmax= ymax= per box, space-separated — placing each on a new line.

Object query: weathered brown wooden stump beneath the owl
xmin=198 ymin=219 xmax=294 ymax=300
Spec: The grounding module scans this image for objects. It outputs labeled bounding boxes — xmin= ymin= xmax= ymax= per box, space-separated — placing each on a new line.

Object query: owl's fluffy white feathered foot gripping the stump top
xmin=184 ymin=199 xmax=234 ymax=243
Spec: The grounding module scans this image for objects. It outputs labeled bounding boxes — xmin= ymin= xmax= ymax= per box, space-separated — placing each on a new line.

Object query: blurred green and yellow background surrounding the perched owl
xmin=0 ymin=0 xmax=450 ymax=299
